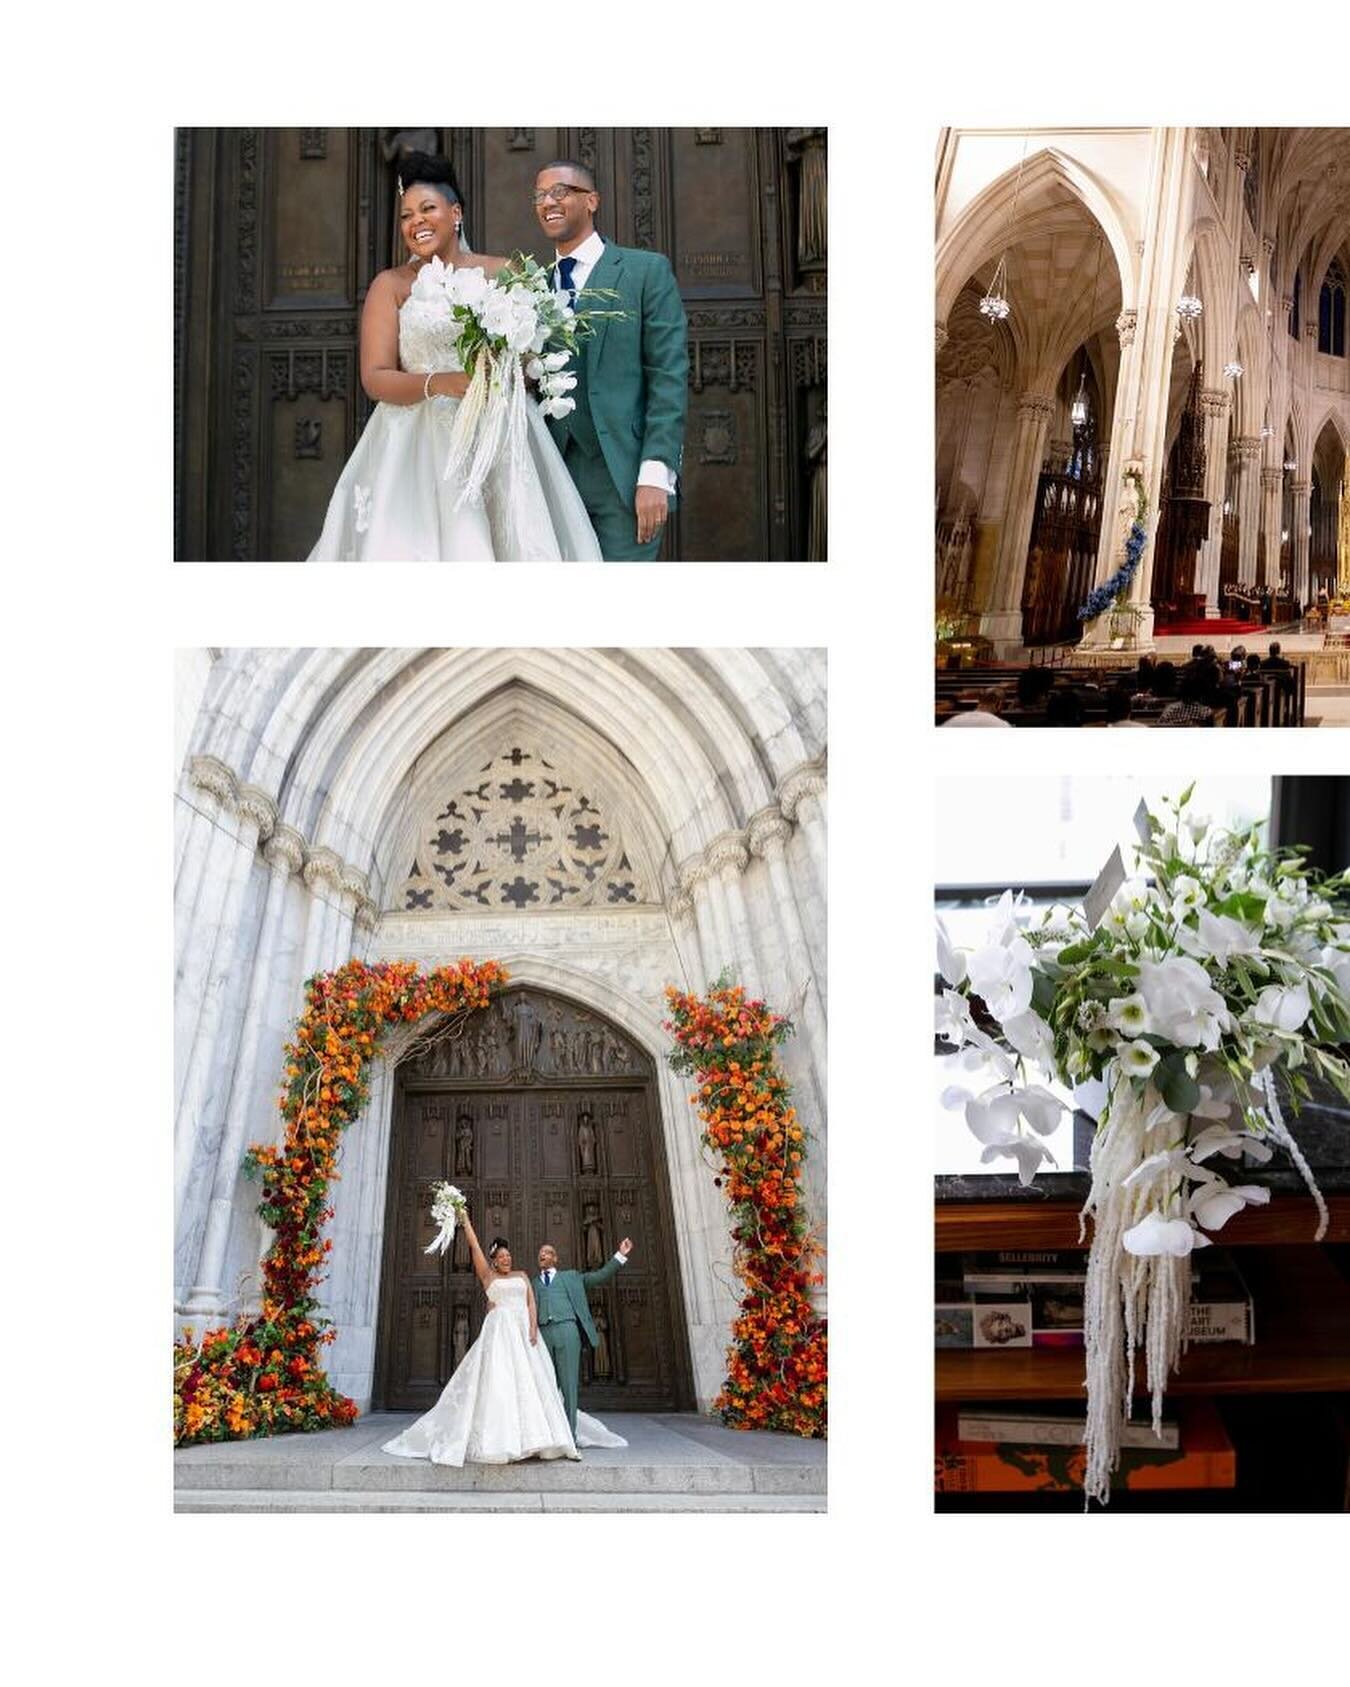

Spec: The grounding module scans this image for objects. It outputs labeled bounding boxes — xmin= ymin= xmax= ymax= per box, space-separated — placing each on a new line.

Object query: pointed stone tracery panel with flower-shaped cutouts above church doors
xmin=395 ymin=744 xmax=651 ymax=913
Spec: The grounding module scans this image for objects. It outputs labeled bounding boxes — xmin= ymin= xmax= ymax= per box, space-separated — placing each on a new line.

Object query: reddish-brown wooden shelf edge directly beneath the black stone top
xmin=935 ymin=1194 xmax=1350 ymax=1253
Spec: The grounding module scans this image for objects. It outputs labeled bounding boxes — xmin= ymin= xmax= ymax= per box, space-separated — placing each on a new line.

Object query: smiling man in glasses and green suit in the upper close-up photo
xmin=535 ymin=159 xmax=689 ymax=562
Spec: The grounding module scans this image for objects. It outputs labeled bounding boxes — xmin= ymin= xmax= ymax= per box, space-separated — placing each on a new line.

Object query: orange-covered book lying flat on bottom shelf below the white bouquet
xmin=935 ymin=1397 xmax=1237 ymax=1493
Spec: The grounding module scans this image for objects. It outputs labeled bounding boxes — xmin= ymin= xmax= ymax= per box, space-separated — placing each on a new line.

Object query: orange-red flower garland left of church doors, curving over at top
xmin=174 ymin=960 xmax=506 ymax=1446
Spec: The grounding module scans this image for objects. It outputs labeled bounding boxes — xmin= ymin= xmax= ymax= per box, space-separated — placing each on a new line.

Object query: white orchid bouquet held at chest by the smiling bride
xmin=412 ymin=253 xmax=624 ymax=504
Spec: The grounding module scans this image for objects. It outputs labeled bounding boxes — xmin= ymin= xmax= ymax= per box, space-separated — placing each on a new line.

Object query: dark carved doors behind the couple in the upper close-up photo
xmin=174 ymin=128 xmax=827 ymax=562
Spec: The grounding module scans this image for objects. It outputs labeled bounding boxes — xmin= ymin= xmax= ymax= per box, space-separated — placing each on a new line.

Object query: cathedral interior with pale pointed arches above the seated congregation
xmin=935 ymin=128 xmax=1350 ymax=656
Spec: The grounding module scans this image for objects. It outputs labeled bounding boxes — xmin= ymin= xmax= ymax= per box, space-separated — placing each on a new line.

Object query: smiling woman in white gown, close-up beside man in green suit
xmin=309 ymin=152 xmax=601 ymax=562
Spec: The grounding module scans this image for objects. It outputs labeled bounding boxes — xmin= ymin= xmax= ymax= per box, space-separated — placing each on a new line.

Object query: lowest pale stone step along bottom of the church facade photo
xmin=174 ymin=1488 xmax=827 ymax=1515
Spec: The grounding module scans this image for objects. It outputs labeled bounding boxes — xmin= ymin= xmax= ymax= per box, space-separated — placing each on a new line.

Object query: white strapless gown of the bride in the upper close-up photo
xmin=309 ymin=273 xmax=601 ymax=562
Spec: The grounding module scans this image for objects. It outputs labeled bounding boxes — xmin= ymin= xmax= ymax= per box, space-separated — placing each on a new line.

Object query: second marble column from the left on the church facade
xmin=174 ymin=784 xmax=277 ymax=1216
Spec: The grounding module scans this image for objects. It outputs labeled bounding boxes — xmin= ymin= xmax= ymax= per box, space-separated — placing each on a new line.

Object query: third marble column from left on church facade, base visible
xmin=179 ymin=825 xmax=304 ymax=1329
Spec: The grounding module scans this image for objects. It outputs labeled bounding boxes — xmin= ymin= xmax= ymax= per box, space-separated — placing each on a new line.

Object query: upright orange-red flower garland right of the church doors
xmin=665 ymin=977 xmax=825 ymax=1437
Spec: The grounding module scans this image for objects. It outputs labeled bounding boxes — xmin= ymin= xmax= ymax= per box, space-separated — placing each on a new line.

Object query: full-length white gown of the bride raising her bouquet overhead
xmin=383 ymin=1277 xmax=628 ymax=1466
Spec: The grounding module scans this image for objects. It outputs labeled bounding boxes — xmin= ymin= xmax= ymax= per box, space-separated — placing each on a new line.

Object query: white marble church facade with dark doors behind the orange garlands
xmin=174 ymin=649 xmax=825 ymax=1410
